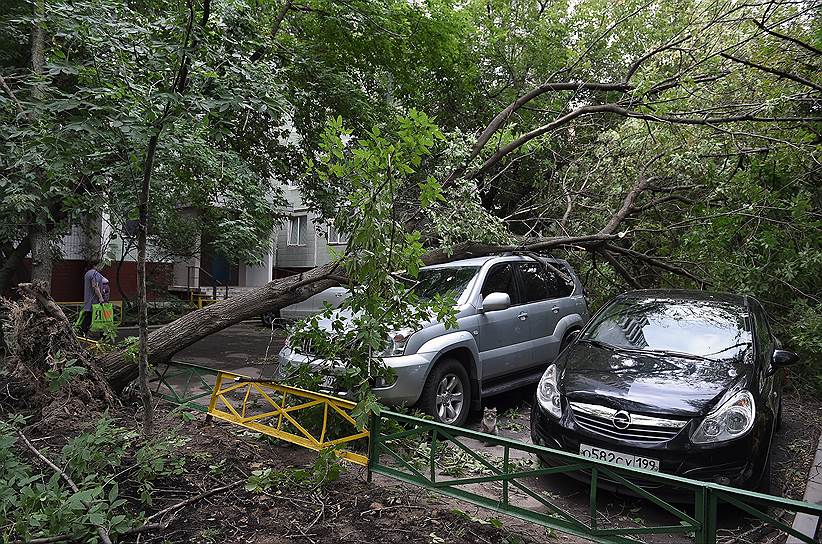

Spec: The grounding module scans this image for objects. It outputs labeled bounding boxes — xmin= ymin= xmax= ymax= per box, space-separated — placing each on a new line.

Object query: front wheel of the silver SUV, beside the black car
xmin=419 ymin=358 xmax=471 ymax=426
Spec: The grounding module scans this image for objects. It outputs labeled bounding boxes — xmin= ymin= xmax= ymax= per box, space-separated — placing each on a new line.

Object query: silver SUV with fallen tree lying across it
xmin=279 ymin=255 xmax=588 ymax=425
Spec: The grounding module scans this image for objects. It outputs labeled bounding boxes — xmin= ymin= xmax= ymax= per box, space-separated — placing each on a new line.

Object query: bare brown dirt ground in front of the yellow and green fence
xmin=98 ymin=411 xmax=583 ymax=544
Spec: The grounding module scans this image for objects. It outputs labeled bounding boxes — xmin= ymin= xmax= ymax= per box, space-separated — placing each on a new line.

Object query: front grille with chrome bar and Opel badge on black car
xmin=569 ymin=402 xmax=688 ymax=442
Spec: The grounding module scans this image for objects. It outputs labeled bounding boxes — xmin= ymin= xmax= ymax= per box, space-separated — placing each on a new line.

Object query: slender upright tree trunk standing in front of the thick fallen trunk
xmin=137 ymin=132 xmax=162 ymax=438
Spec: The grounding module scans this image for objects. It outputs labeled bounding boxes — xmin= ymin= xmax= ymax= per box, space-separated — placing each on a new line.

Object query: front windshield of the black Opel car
xmin=580 ymin=298 xmax=751 ymax=360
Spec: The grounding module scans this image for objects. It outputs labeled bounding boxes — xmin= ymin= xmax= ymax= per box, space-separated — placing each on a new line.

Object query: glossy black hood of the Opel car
xmin=557 ymin=343 xmax=750 ymax=417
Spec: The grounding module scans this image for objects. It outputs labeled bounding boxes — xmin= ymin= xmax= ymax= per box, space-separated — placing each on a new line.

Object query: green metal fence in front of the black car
xmin=368 ymin=411 xmax=822 ymax=544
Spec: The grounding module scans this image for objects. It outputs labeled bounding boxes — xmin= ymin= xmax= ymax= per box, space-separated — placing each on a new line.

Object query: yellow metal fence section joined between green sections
xmin=208 ymin=371 xmax=369 ymax=465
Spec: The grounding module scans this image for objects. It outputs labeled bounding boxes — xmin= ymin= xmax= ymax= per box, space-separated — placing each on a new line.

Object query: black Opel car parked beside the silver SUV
xmin=531 ymin=289 xmax=798 ymax=490
